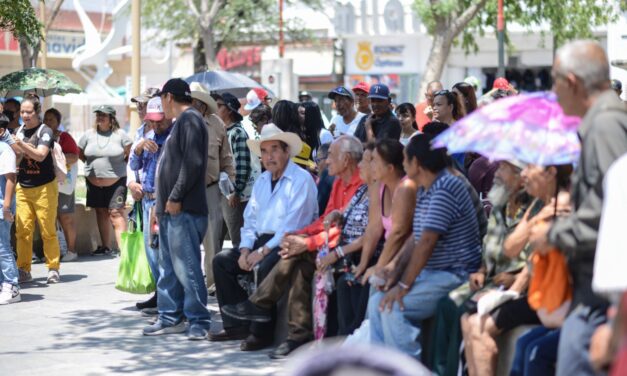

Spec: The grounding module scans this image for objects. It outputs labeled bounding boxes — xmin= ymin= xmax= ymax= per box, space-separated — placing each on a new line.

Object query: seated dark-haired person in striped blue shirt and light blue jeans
xmin=360 ymin=134 xmax=481 ymax=357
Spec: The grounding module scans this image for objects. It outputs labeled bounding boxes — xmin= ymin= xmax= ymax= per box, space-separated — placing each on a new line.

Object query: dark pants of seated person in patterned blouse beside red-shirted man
xmin=336 ymin=273 xmax=370 ymax=336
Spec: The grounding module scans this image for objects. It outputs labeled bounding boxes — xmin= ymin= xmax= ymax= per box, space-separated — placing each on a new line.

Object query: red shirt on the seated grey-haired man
xmin=296 ymin=168 xmax=363 ymax=251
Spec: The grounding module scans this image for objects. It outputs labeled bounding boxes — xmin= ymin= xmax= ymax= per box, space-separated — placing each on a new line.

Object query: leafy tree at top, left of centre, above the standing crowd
xmin=142 ymin=0 xmax=320 ymax=72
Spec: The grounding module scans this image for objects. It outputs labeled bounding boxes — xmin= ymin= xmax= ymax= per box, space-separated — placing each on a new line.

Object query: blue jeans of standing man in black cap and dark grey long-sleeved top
xmin=157 ymin=212 xmax=211 ymax=330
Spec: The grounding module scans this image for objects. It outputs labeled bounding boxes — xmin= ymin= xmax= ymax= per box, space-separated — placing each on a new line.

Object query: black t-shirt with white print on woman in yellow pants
xmin=17 ymin=124 xmax=55 ymax=188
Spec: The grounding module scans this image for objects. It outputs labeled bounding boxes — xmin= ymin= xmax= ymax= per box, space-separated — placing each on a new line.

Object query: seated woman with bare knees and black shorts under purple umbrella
xmin=461 ymin=165 xmax=572 ymax=375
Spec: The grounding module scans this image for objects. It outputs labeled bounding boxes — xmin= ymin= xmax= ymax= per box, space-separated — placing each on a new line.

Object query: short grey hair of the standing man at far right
xmin=557 ymin=39 xmax=610 ymax=93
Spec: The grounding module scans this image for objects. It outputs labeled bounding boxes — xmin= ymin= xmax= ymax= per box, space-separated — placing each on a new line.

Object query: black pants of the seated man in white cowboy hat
xmin=213 ymin=235 xmax=280 ymax=338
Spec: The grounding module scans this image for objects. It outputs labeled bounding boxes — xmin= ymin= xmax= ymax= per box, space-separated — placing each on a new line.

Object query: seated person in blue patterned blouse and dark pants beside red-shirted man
xmin=318 ymin=144 xmax=381 ymax=335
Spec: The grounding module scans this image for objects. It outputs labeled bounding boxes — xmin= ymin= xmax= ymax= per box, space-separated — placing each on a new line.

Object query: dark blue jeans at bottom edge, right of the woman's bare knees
xmin=510 ymin=326 xmax=560 ymax=376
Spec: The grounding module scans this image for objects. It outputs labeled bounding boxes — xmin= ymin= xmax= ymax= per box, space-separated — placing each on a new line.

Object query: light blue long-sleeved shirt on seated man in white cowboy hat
xmin=240 ymin=160 xmax=318 ymax=249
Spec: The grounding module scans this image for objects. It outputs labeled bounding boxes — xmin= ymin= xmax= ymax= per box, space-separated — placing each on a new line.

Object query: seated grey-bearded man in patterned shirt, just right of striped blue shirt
xmin=428 ymin=161 xmax=529 ymax=375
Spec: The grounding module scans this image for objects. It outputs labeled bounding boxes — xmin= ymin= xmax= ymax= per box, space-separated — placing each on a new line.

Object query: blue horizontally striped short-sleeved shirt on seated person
xmin=414 ymin=170 xmax=481 ymax=273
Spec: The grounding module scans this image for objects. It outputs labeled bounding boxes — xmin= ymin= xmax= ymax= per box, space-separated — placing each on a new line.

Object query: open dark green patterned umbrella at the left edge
xmin=0 ymin=68 xmax=83 ymax=97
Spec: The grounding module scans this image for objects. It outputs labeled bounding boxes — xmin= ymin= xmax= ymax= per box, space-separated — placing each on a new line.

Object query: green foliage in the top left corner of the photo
xmin=0 ymin=0 xmax=42 ymax=46
